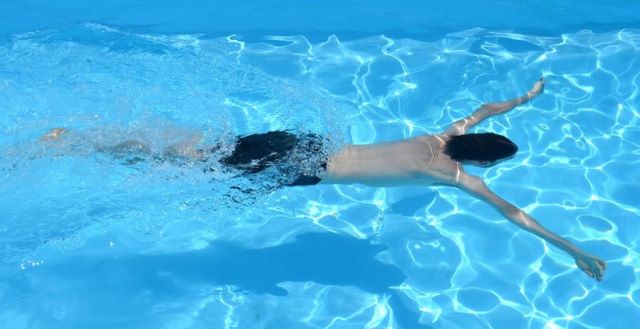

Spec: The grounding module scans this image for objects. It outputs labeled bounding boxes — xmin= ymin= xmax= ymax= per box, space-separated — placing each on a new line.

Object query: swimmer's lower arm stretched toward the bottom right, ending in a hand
xmin=458 ymin=172 xmax=607 ymax=281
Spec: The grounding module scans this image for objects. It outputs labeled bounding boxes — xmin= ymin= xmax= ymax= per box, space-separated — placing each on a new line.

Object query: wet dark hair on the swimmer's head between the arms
xmin=444 ymin=133 xmax=518 ymax=162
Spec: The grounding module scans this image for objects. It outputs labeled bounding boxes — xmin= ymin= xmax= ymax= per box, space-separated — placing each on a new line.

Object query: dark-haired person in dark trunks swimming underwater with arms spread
xmin=41 ymin=78 xmax=607 ymax=281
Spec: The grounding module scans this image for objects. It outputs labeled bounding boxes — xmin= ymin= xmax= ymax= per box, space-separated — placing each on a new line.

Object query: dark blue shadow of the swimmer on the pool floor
xmin=38 ymin=233 xmax=426 ymax=328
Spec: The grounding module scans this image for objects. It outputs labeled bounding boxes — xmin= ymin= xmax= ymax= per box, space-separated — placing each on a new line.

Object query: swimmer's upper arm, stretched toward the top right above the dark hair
xmin=445 ymin=78 xmax=544 ymax=135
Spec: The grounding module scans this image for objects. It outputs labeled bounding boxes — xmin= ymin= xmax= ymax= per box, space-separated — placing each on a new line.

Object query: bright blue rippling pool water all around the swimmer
xmin=0 ymin=1 xmax=640 ymax=328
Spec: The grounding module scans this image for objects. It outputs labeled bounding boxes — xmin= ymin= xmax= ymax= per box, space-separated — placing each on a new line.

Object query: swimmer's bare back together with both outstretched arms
xmin=320 ymin=79 xmax=607 ymax=281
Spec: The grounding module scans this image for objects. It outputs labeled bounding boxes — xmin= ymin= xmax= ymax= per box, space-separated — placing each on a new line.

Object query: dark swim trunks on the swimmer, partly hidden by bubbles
xmin=220 ymin=131 xmax=327 ymax=186
